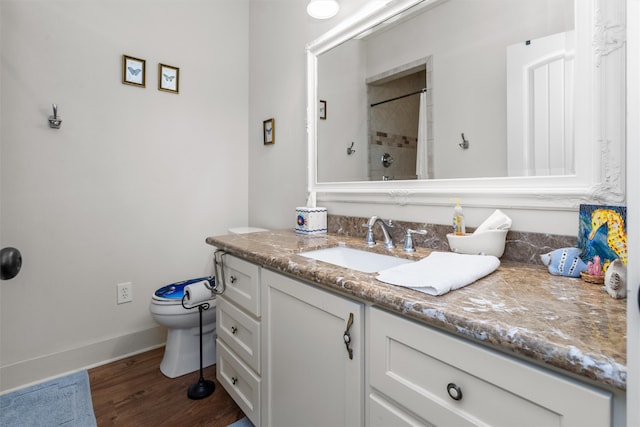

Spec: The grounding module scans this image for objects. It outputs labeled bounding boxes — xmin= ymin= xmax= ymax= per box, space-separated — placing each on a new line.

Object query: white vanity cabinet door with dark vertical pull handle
xmin=262 ymin=270 xmax=364 ymax=427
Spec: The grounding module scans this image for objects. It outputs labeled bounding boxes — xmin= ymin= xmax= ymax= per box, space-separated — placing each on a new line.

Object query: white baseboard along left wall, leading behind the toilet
xmin=0 ymin=326 xmax=167 ymax=394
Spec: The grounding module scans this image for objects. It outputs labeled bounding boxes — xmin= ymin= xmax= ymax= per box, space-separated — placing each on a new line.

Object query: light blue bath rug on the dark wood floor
xmin=0 ymin=371 xmax=96 ymax=427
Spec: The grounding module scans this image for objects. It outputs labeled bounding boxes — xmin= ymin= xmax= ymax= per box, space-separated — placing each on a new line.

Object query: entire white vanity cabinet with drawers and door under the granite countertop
xmin=217 ymin=255 xmax=624 ymax=427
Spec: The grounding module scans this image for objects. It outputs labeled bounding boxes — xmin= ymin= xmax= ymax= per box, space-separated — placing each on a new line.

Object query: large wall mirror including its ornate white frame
xmin=307 ymin=0 xmax=625 ymax=209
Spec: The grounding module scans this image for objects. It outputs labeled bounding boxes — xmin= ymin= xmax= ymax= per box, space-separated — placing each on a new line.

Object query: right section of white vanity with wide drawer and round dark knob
xmin=366 ymin=307 xmax=612 ymax=427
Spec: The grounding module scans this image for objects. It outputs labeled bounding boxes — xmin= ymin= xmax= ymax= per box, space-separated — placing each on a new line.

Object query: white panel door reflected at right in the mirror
xmin=507 ymin=31 xmax=574 ymax=176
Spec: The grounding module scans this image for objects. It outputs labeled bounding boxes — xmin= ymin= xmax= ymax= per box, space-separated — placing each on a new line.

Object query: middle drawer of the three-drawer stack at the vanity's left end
xmin=216 ymin=296 xmax=260 ymax=374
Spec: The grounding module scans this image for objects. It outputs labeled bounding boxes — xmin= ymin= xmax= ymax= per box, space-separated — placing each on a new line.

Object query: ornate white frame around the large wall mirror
xmin=307 ymin=0 xmax=626 ymax=210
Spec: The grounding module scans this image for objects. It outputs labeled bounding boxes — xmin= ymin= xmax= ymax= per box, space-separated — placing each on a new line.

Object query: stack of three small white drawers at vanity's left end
xmin=216 ymin=254 xmax=262 ymax=427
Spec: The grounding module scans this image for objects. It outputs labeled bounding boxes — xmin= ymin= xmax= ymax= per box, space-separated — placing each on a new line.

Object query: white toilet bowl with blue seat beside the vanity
xmin=149 ymin=278 xmax=216 ymax=378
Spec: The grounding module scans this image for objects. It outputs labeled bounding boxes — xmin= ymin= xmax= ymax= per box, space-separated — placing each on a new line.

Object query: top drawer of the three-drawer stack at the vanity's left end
xmin=223 ymin=254 xmax=260 ymax=317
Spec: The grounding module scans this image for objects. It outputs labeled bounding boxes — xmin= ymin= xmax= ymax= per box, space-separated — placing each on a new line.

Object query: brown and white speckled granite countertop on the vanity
xmin=206 ymin=230 xmax=627 ymax=390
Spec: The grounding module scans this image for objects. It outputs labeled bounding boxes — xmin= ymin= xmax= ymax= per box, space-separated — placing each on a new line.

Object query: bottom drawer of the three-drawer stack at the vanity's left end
xmin=216 ymin=339 xmax=261 ymax=427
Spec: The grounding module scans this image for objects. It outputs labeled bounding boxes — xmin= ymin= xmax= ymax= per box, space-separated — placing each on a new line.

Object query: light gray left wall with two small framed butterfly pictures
xmin=0 ymin=0 xmax=249 ymax=389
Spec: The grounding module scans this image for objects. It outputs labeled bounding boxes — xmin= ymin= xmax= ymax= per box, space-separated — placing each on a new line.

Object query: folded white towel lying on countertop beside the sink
xmin=376 ymin=252 xmax=500 ymax=295
